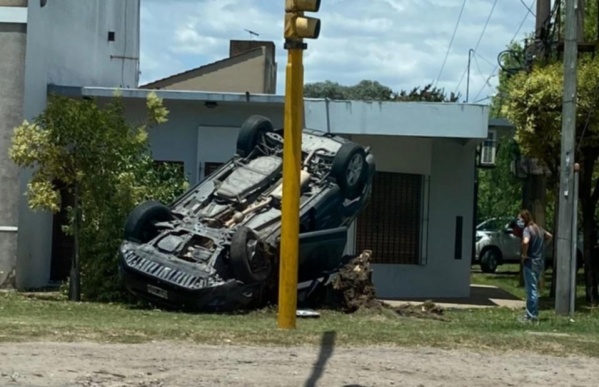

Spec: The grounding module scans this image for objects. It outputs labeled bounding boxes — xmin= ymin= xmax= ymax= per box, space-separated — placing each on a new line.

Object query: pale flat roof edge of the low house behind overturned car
xmin=48 ymin=85 xmax=489 ymax=140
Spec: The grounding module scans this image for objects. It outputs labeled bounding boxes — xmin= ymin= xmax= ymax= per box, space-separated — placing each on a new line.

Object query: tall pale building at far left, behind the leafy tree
xmin=0 ymin=0 xmax=140 ymax=288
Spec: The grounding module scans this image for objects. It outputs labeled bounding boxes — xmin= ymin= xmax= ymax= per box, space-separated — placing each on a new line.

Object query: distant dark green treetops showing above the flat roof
xmin=304 ymin=80 xmax=459 ymax=102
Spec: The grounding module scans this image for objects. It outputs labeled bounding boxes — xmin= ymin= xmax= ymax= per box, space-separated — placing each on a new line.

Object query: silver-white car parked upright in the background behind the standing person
xmin=473 ymin=217 xmax=583 ymax=273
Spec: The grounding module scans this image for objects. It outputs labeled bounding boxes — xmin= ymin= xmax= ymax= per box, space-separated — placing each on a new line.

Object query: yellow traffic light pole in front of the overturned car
xmin=278 ymin=0 xmax=320 ymax=329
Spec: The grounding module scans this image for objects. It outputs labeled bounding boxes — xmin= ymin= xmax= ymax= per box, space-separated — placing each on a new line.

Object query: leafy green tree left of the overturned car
xmin=9 ymin=93 xmax=187 ymax=300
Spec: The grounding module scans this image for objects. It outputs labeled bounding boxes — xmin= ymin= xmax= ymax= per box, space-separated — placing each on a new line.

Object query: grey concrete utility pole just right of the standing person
xmin=554 ymin=0 xmax=578 ymax=315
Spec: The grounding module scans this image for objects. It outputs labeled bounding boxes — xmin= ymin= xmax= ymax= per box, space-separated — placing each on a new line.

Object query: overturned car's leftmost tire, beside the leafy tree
xmin=124 ymin=201 xmax=173 ymax=243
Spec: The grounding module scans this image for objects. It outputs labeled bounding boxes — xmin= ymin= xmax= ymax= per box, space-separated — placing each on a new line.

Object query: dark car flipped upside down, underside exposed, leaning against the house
xmin=119 ymin=116 xmax=375 ymax=310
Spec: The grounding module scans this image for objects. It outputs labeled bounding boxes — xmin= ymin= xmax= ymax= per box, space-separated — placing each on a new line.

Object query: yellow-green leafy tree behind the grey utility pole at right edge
xmin=507 ymin=58 xmax=599 ymax=303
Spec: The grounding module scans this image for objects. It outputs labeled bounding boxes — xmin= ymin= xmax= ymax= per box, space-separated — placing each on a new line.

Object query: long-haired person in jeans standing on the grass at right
xmin=516 ymin=210 xmax=553 ymax=323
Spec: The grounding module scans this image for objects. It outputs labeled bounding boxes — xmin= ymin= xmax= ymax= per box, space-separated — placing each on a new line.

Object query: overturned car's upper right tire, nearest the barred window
xmin=331 ymin=142 xmax=368 ymax=200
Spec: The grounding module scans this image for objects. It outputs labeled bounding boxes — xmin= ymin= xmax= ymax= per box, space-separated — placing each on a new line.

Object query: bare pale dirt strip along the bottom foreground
xmin=0 ymin=342 xmax=599 ymax=387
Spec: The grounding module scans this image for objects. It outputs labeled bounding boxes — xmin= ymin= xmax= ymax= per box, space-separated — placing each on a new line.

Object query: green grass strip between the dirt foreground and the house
xmin=0 ymin=266 xmax=599 ymax=357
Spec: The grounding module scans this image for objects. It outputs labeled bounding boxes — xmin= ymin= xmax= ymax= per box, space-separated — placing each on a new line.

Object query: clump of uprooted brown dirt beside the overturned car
xmin=326 ymin=250 xmax=446 ymax=320
